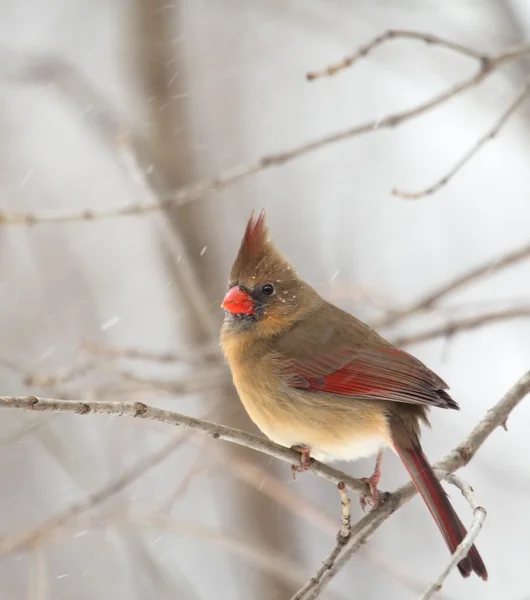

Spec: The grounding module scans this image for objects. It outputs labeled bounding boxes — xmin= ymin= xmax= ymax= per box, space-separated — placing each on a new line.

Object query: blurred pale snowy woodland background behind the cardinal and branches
xmin=0 ymin=0 xmax=530 ymax=600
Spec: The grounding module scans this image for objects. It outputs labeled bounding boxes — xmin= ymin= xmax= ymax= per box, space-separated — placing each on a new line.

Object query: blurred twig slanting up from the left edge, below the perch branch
xmin=0 ymin=428 xmax=188 ymax=556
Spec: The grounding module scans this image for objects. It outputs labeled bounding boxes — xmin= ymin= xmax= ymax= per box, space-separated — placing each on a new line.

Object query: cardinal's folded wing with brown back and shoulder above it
xmin=278 ymin=305 xmax=458 ymax=409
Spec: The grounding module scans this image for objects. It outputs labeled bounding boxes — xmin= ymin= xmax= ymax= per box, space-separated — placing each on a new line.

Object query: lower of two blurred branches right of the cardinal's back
xmin=392 ymin=306 xmax=530 ymax=347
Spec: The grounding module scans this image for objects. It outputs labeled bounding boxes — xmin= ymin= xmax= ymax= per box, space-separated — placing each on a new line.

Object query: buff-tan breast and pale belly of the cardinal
xmin=223 ymin=330 xmax=389 ymax=462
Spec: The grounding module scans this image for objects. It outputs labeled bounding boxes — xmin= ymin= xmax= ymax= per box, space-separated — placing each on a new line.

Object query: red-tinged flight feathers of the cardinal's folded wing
xmin=288 ymin=347 xmax=458 ymax=408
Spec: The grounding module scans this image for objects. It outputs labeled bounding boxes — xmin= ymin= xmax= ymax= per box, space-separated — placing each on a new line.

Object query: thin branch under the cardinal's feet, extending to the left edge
xmin=0 ymin=396 xmax=369 ymax=500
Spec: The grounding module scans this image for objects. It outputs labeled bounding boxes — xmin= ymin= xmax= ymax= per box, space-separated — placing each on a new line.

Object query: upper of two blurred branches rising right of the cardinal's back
xmin=374 ymin=244 xmax=530 ymax=328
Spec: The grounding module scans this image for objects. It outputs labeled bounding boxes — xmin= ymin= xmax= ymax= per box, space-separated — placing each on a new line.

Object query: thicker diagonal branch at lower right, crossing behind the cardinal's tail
xmin=292 ymin=371 xmax=530 ymax=600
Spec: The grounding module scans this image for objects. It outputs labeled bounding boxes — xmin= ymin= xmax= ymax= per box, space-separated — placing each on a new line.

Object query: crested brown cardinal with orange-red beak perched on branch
xmin=221 ymin=212 xmax=488 ymax=580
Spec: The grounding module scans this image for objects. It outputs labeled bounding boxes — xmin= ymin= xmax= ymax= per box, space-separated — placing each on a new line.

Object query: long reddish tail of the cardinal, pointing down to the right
xmin=394 ymin=442 xmax=488 ymax=581
